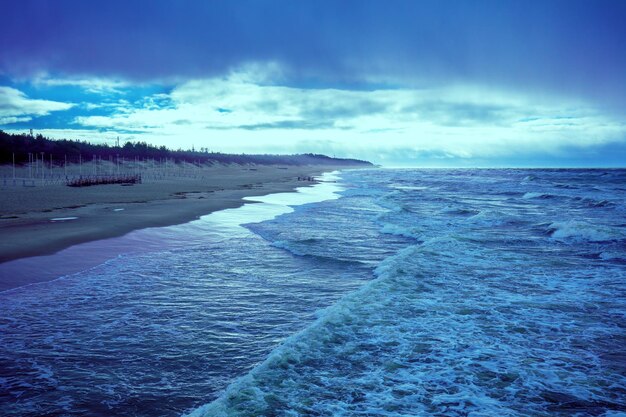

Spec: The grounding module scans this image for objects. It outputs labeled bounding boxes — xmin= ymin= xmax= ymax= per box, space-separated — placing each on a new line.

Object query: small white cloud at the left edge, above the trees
xmin=0 ymin=86 xmax=74 ymax=125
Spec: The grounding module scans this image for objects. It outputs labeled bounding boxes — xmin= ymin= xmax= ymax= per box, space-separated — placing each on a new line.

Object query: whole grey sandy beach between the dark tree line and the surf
xmin=0 ymin=165 xmax=346 ymax=263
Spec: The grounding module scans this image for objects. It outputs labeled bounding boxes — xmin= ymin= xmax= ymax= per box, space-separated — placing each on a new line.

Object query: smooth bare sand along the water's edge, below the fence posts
xmin=0 ymin=166 xmax=353 ymax=265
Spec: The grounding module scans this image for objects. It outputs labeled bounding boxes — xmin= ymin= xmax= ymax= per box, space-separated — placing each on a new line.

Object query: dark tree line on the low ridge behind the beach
xmin=0 ymin=130 xmax=372 ymax=165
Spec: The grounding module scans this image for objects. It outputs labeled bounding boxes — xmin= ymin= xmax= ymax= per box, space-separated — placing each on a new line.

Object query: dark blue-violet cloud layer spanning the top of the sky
xmin=0 ymin=0 xmax=626 ymax=107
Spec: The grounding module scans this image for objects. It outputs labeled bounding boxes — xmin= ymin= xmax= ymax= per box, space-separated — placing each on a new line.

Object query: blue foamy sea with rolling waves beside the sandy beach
xmin=0 ymin=169 xmax=626 ymax=417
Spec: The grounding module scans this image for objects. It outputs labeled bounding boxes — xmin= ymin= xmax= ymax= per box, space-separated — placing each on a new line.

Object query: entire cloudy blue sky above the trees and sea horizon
xmin=0 ymin=0 xmax=626 ymax=167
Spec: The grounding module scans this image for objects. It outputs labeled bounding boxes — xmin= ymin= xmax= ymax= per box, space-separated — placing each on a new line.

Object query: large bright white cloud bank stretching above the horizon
xmin=62 ymin=66 xmax=626 ymax=164
